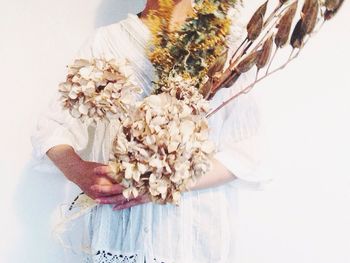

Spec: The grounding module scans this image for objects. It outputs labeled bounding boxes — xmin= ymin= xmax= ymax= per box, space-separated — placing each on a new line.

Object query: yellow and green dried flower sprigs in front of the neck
xmin=148 ymin=0 xmax=236 ymax=92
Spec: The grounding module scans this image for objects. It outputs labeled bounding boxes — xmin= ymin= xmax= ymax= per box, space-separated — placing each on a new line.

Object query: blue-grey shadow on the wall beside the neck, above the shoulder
xmin=95 ymin=0 xmax=146 ymax=27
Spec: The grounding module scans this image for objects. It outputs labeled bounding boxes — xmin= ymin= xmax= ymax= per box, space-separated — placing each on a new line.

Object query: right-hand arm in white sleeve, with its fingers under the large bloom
xmin=96 ymin=95 xmax=265 ymax=210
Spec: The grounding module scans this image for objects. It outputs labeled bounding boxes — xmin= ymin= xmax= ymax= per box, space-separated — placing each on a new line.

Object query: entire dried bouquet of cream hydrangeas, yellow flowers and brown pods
xmin=59 ymin=0 xmax=344 ymax=208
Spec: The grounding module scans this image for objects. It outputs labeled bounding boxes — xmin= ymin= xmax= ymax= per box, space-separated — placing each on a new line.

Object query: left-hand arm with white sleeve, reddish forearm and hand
xmin=31 ymin=27 xmax=122 ymax=199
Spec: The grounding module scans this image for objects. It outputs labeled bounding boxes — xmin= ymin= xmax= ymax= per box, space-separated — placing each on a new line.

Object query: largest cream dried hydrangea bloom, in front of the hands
xmin=110 ymin=79 xmax=214 ymax=204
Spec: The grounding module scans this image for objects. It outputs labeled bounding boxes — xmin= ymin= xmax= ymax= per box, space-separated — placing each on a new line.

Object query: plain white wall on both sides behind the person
xmin=0 ymin=0 xmax=350 ymax=263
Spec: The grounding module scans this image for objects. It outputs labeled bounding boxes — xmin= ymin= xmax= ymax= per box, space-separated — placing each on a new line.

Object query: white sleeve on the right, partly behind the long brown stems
xmin=211 ymin=4 xmax=272 ymax=186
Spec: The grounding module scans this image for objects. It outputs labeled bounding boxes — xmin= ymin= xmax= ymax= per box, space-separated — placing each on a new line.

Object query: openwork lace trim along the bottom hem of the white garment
xmin=84 ymin=250 xmax=166 ymax=263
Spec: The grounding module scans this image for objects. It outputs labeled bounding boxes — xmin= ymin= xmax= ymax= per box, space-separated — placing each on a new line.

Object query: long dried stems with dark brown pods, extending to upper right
xmin=202 ymin=0 xmax=344 ymax=118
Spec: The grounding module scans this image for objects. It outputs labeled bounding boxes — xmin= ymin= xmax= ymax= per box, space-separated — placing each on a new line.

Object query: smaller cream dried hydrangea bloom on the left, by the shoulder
xmin=59 ymin=59 xmax=142 ymax=122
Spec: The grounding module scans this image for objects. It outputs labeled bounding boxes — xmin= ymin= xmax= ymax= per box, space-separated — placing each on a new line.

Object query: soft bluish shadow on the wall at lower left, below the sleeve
xmin=10 ymin=159 xmax=81 ymax=263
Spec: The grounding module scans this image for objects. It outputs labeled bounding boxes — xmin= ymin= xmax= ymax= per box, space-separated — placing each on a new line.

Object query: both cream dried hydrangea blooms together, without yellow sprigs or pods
xmin=60 ymin=59 xmax=214 ymax=204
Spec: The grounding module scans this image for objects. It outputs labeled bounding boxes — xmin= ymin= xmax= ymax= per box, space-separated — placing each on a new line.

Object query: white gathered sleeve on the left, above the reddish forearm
xmin=31 ymin=29 xmax=99 ymax=159
